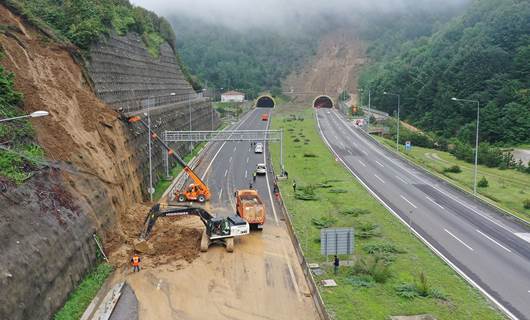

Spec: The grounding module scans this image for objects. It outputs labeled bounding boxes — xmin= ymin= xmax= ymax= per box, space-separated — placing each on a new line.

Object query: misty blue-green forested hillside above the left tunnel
xmin=169 ymin=16 xmax=318 ymax=98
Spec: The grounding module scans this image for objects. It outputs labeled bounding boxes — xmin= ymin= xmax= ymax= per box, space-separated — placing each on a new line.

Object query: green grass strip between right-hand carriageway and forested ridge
xmin=375 ymin=137 xmax=530 ymax=222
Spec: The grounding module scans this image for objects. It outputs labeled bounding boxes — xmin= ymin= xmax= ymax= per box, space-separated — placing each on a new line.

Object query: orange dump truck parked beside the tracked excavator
xmin=236 ymin=190 xmax=265 ymax=229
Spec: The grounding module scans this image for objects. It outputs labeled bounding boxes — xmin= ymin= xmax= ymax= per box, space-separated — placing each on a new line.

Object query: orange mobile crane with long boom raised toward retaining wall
xmin=128 ymin=116 xmax=211 ymax=203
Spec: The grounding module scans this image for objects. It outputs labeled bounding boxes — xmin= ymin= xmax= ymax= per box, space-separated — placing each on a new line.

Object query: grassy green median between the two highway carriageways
xmin=271 ymin=107 xmax=504 ymax=319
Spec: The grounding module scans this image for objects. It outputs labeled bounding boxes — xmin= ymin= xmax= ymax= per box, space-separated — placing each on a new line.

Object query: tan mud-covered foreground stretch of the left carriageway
xmin=126 ymin=226 xmax=316 ymax=319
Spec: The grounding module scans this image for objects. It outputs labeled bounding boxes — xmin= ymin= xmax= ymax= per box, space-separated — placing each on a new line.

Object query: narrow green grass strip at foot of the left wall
xmin=53 ymin=263 xmax=113 ymax=320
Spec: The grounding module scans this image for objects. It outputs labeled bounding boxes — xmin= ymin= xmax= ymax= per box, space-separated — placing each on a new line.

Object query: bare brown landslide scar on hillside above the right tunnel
xmin=283 ymin=30 xmax=366 ymax=100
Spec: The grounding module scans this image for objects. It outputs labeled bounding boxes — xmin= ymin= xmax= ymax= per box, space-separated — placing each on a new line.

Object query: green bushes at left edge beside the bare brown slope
xmin=0 ymin=49 xmax=44 ymax=182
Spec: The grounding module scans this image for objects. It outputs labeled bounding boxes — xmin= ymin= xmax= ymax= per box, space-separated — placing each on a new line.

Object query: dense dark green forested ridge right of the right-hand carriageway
xmin=361 ymin=0 xmax=530 ymax=144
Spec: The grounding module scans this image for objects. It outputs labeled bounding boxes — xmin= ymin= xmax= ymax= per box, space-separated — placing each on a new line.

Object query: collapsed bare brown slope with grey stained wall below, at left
xmin=0 ymin=5 xmax=142 ymax=319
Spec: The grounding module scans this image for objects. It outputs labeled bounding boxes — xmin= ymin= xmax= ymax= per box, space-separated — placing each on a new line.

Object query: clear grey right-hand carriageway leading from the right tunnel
xmin=316 ymin=109 xmax=530 ymax=319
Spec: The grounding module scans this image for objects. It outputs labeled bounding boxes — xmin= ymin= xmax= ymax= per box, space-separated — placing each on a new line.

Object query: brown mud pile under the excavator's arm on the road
xmin=105 ymin=204 xmax=204 ymax=268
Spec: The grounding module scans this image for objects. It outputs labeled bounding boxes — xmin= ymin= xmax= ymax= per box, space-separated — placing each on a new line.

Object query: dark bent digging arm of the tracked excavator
xmin=140 ymin=203 xmax=213 ymax=240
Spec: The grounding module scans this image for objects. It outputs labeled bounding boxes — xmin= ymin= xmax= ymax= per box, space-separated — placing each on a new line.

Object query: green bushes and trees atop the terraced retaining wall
xmin=5 ymin=0 xmax=201 ymax=90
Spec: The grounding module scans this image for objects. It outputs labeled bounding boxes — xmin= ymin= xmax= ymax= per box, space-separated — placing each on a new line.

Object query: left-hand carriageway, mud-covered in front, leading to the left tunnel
xmin=128 ymin=109 xmax=318 ymax=320
